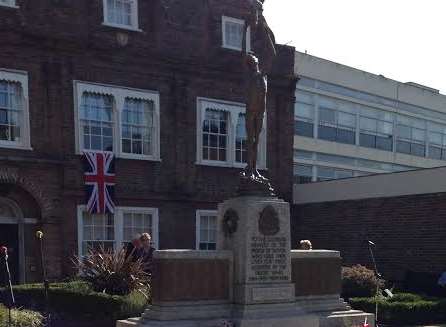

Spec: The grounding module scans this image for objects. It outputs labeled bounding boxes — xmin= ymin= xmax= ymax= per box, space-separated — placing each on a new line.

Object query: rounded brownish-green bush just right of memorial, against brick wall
xmin=342 ymin=265 xmax=384 ymax=298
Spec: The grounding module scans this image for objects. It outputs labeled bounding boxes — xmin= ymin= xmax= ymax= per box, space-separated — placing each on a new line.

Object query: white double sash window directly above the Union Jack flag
xmin=74 ymin=81 xmax=160 ymax=160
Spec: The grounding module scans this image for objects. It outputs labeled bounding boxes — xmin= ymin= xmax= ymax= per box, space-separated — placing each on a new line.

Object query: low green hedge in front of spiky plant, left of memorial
xmin=0 ymin=281 xmax=147 ymax=320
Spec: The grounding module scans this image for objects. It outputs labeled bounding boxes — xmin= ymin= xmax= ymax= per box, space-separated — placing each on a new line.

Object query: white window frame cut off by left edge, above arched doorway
xmin=0 ymin=68 xmax=32 ymax=150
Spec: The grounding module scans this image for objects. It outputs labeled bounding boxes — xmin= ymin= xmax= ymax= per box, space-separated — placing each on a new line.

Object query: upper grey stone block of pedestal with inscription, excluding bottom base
xmin=217 ymin=196 xmax=294 ymax=304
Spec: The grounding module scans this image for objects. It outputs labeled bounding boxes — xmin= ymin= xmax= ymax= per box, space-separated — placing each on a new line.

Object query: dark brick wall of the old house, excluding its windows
xmin=0 ymin=0 xmax=296 ymax=276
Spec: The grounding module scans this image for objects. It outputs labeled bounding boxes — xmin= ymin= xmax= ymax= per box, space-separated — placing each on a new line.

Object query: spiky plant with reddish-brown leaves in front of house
xmin=74 ymin=246 xmax=150 ymax=296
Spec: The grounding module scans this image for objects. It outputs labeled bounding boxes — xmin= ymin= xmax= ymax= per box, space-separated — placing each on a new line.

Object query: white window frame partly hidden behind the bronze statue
xmin=196 ymin=97 xmax=267 ymax=170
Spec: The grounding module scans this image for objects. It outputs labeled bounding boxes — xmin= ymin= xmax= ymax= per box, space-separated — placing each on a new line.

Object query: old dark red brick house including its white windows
xmin=0 ymin=0 xmax=296 ymax=282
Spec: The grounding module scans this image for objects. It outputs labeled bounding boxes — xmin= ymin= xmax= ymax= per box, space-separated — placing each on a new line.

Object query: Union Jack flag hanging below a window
xmin=84 ymin=152 xmax=115 ymax=214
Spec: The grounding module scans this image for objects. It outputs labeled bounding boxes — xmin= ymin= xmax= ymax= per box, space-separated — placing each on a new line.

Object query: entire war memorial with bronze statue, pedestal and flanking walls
xmin=117 ymin=1 xmax=374 ymax=327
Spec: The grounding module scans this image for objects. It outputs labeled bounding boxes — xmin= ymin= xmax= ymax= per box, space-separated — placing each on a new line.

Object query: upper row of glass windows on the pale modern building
xmin=294 ymin=86 xmax=446 ymax=160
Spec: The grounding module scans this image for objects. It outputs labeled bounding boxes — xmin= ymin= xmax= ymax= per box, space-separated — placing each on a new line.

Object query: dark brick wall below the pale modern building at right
xmin=292 ymin=193 xmax=446 ymax=280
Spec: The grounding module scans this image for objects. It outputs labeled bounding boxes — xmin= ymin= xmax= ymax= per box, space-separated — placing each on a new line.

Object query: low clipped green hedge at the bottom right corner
xmin=349 ymin=293 xmax=446 ymax=326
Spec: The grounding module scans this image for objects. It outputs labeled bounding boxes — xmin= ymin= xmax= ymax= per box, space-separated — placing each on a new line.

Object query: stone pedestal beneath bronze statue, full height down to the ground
xmin=217 ymin=196 xmax=317 ymax=327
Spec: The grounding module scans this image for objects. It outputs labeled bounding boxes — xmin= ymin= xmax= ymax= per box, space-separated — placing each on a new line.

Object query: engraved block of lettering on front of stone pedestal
xmin=248 ymin=236 xmax=289 ymax=282
